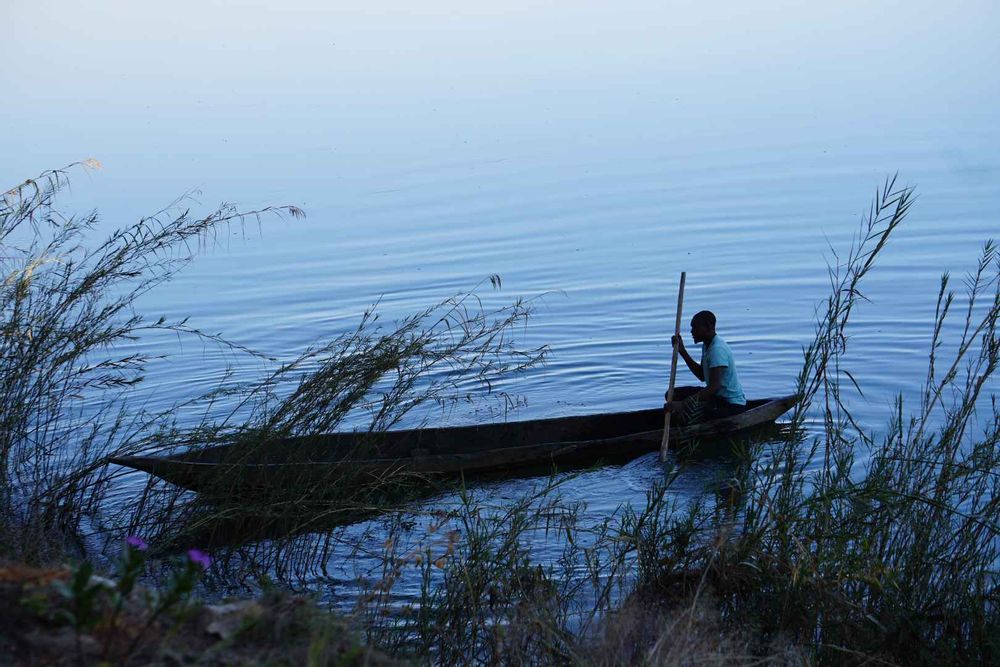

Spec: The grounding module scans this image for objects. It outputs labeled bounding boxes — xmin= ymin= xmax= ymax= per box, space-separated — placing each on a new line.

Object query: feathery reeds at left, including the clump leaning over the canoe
xmin=0 ymin=161 xmax=546 ymax=560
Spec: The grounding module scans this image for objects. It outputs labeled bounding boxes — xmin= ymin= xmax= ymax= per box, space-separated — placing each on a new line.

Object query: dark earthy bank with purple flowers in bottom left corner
xmin=0 ymin=548 xmax=403 ymax=667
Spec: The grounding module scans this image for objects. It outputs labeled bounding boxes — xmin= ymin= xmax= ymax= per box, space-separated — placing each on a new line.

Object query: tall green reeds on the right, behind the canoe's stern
xmin=706 ymin=180 xmax=1000 ymax=662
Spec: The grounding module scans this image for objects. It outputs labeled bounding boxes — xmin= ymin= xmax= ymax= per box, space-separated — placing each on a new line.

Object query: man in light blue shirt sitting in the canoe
xmin=663 ymin=310 xmax=747 ymax=424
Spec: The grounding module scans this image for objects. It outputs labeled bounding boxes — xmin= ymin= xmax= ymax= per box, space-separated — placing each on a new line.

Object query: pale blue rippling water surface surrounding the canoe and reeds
xmin=0 ymin=0 xmax=1000 ymax=604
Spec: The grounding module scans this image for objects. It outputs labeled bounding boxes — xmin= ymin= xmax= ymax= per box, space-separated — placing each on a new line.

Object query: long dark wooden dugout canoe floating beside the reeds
xmin=109 ymin=388 xmax=799 ymax=497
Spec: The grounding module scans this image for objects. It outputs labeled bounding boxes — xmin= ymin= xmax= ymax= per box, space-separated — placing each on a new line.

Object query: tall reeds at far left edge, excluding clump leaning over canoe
xmin=0 ymin=160 xmax=302 ymax=558
